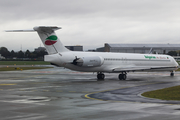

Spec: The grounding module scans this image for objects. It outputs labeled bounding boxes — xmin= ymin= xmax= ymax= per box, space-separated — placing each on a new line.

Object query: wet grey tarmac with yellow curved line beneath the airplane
xmin=0 ymin=68 xmax=180 ymax=120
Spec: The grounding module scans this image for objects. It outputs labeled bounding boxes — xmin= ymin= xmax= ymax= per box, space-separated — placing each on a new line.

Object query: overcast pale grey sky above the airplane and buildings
xmin=0 ymin=0 xmax=180 ymax=51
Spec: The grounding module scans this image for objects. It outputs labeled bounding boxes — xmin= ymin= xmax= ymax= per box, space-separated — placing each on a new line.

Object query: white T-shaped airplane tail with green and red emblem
xmin=6 ymin=26 xmax=69 ymax=54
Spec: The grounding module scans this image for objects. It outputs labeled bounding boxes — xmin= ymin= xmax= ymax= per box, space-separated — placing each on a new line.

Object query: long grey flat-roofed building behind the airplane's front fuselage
xmin=102 ymin=43 xmax=180 ymax=54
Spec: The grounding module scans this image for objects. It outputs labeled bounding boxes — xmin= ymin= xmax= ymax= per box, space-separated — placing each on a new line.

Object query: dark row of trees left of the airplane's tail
xmin=0 ymin=47 xmax=47 ymax=60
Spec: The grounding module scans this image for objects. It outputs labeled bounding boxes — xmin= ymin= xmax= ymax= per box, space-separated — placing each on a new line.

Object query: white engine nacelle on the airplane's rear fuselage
xmin=73 ymin=56 xmax=104 ymax=67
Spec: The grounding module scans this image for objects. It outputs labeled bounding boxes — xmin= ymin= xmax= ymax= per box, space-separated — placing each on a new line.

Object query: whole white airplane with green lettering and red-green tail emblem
xmin=7 ymin=26 xmax=179 ymax=80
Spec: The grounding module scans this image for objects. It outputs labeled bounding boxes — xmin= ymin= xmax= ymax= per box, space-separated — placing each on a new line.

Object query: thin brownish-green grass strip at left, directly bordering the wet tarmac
xmin=0 ymin=67 xmax=52 ymax=71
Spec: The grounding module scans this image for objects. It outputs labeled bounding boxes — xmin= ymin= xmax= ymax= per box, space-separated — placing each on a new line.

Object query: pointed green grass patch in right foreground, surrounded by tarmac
xmin=142 ymin=86 xmax=180 ymax=100
